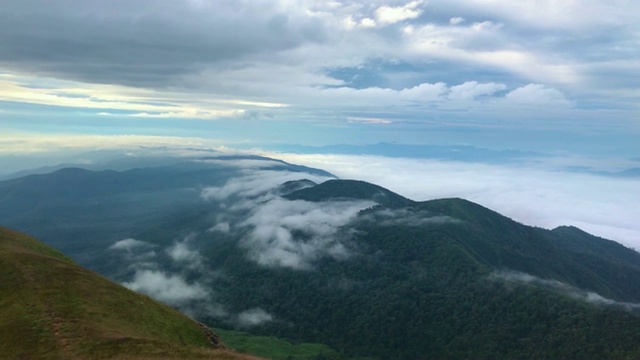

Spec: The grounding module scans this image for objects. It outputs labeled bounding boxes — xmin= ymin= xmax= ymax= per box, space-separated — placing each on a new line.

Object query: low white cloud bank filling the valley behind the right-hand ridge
xmin=272 ymin=154 xmax=640 ymax=249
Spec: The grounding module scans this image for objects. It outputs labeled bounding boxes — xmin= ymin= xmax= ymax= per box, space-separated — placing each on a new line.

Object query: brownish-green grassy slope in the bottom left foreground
xmin=0 ymin=228 xmax=262 ymax=359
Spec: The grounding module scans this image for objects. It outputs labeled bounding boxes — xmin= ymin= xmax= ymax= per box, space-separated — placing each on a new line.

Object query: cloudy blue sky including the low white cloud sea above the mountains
xmin=0 ymin=0 xmax=640 ymax=249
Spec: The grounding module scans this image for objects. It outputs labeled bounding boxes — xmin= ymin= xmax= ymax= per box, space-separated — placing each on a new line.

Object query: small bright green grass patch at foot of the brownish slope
xmin=214 ymin=329 xmax=337 ymax=360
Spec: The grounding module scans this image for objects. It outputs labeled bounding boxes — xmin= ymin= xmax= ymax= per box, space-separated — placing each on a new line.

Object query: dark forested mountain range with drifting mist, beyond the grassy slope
xmin=0 ymin=157 xmax=640 ymax=359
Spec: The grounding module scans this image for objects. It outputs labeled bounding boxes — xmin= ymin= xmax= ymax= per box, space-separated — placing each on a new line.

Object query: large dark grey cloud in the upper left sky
xmin=0 ymin=0 xmax=325 ymax=87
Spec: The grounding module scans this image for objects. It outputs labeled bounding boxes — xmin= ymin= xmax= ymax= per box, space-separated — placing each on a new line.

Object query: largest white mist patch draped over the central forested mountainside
xmin=202 ymin=165 xmax=364 ymax=269
